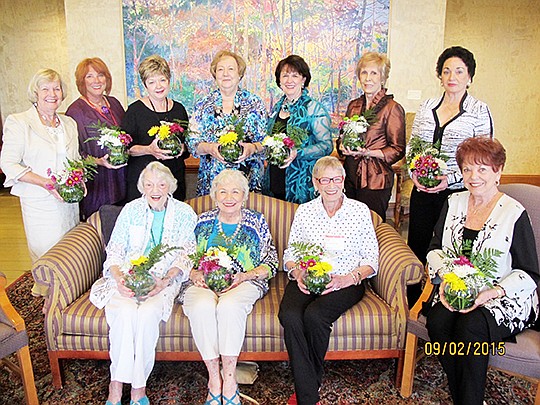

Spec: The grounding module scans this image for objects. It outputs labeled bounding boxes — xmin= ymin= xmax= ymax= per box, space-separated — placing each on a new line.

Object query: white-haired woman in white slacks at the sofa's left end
xmin=90 ymin=162 xmax=197 ymax=405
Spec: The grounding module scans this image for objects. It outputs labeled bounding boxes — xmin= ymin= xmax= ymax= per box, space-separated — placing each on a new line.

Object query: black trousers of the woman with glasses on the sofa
xmin=279 ymin=281 xmax=365 ymax=405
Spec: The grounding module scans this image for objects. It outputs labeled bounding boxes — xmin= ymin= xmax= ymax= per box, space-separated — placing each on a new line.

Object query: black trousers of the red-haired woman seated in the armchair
xmin=426 ymin=302 xmax=517 ymax=405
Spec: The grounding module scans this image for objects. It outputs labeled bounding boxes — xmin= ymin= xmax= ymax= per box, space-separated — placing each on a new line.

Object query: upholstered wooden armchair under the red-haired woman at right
xmin=401 ymin=184 xmax=540 ymax=405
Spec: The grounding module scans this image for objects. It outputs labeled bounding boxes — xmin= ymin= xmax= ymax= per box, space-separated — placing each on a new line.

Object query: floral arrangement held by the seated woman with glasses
xmin=291 ymin=242 xmax=332 ymax=294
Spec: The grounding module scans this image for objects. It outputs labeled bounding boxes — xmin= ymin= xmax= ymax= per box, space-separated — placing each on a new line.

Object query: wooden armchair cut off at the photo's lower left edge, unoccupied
xmin=0 ymin=272 xmax=39 ymax=405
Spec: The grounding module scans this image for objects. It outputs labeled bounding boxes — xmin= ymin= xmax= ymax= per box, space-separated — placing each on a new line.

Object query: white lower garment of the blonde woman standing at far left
xmin=20 ymin=195 xmax=79 ymax=263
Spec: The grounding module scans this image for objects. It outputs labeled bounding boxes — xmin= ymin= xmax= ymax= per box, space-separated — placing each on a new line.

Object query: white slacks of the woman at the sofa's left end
xmin=105 ymin=291 xmax=164 ymax=388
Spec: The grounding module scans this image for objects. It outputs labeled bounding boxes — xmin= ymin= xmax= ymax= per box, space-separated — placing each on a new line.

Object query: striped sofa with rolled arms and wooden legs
xmin=32 ymin=193 xmax=423 ymax=388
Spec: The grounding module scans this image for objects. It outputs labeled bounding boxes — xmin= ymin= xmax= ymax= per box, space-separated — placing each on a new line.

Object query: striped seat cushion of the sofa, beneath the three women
xmin=60 ymin=272 xmax=397 ymax=352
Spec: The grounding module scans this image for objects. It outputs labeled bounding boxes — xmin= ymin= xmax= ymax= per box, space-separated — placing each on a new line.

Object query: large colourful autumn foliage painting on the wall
xmin=123 ymin=0 xmax=390 ymax=116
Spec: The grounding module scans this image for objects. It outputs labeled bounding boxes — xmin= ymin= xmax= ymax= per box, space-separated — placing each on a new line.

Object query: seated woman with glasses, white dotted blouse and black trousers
xmin=279 ymin=156 xmax=379 ymax=405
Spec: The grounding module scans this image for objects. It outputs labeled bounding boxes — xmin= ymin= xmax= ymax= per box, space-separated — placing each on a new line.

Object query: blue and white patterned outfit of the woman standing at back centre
xmin=187 ymin=89 xmax=267 ymax=196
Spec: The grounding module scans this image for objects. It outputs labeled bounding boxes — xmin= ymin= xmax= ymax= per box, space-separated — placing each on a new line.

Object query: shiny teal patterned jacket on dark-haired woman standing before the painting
xmin=263 ymin=89 xmax=334 ymax=204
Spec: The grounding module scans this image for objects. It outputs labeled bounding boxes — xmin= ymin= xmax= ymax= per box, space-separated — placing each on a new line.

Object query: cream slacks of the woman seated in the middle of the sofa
xmin=182 ymin=282 xmax=261 ymax=360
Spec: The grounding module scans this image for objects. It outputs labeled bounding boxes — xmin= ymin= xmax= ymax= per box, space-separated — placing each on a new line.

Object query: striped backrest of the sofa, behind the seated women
xmin=186 ymin=193 xmax=298 ymax=269
